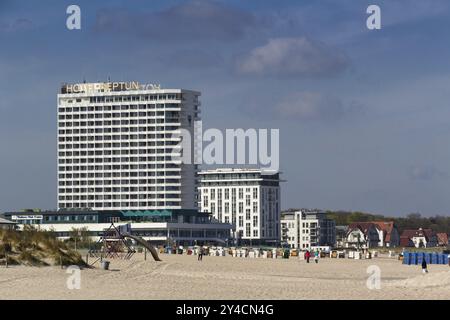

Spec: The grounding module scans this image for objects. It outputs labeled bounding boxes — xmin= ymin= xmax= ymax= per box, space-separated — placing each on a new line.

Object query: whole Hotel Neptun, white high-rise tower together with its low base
xmin=0 ymin=82 xmax=234 ymax=245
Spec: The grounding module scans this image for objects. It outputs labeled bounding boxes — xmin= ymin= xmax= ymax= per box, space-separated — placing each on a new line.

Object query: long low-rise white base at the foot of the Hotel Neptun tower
xmin=5 ymin=209 xmax=233 ymax=245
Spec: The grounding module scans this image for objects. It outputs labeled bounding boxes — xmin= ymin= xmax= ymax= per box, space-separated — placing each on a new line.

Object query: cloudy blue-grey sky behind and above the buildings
xmin=0 ymin=0 xmax=450 ymax=216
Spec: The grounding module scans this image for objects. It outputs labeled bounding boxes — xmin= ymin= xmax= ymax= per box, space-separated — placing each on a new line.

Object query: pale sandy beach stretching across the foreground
xmin=0 ymin=254 xmax=450 ymax=300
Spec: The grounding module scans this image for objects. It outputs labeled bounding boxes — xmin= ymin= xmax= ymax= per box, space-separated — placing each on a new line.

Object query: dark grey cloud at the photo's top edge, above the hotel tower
xmin=95 ymin=0 xmax=258 ymax=42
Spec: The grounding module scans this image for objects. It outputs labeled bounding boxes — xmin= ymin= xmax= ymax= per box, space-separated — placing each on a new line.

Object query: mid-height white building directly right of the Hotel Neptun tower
xmin=199 ymin=168 xmax=280 ymax=245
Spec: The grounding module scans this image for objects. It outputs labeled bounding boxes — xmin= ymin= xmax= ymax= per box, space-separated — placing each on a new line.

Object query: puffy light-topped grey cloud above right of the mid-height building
xmin=236 ymin=37 xmax=348 ymax=76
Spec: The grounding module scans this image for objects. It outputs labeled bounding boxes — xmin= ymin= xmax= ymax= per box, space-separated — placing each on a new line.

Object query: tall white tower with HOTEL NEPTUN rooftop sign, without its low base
xmin=57 ymin=82 xmax=200 ymax=210
